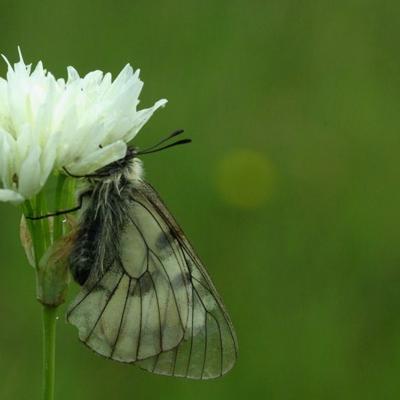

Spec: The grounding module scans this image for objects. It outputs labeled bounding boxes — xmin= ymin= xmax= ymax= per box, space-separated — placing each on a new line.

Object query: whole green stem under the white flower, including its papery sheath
xmin=23 ymin=175 xmax=75 ymax=400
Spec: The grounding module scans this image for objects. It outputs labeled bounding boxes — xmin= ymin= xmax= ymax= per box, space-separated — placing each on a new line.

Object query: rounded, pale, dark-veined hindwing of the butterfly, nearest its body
xmin=67 ymin=194 xmax=192 ymax=362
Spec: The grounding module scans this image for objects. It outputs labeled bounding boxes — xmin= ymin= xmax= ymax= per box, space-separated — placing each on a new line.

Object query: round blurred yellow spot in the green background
xmin=217 ymin=149 xmax=275 ymax=208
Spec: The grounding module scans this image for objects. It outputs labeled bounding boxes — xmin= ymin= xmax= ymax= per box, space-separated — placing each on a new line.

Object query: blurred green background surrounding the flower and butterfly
xmin=0 ymin=0 xmax=400 ymax=400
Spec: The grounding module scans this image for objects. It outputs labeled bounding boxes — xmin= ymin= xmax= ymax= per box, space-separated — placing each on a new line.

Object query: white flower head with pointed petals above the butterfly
xmin=0 ymin=49 xmax=166 ymax=202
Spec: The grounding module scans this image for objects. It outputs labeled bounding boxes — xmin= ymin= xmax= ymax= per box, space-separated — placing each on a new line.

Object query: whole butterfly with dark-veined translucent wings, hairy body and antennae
xmin=52 ymin=131 xmax=238 ymax=379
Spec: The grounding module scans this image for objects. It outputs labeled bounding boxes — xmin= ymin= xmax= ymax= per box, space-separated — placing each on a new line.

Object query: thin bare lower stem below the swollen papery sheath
xmin=42 ymin=304 xmax=57 ymax=400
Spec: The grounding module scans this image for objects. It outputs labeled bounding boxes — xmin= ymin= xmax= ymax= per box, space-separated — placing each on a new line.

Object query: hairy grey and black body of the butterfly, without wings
xmin=69 ymin=159 xmax=143 ymax=285
